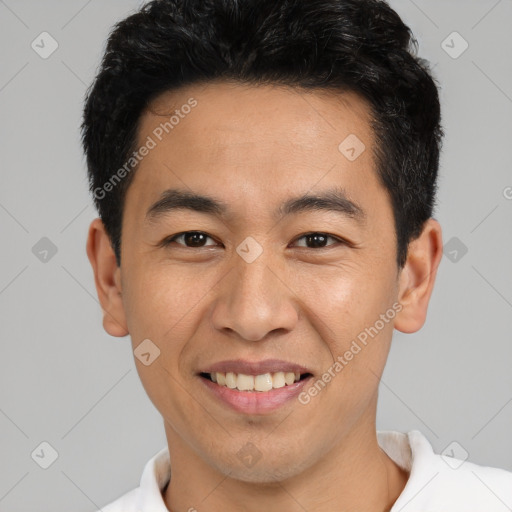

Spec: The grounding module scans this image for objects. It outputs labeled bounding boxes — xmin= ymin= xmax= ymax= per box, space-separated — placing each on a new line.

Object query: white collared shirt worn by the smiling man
xmin=98 ymin=430 xmax=512 ymax=512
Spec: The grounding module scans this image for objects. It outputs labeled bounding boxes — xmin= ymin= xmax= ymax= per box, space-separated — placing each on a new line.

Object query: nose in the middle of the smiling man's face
xmin=212 ymin=251 xmax=299 ymax=341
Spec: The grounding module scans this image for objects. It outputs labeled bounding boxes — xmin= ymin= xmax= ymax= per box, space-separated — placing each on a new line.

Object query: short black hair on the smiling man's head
xmin=82 ymin=0 xmax=444 ymax=268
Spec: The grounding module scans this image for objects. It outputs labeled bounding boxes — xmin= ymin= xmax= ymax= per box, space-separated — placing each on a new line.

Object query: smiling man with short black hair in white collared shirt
xmin=83 ymin=0 xmax=512 ymax=512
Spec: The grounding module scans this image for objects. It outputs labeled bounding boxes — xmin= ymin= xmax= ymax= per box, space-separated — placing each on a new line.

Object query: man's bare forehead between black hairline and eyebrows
xmin=127 ymin=82 xmax=383 ymax=226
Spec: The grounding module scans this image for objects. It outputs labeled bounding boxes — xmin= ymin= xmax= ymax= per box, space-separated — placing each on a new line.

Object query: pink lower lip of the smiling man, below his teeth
xmin=199 ymin=375 xmax=312 ymax=414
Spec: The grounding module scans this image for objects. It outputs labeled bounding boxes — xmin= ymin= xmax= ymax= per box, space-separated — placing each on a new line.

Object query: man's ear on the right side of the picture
xmin=395 ymin=218 xmax=443 ymax=333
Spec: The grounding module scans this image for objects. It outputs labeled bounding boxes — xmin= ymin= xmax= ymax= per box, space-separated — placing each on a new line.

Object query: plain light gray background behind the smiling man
xmin=0 ymin=0 xmax=512 ymax=512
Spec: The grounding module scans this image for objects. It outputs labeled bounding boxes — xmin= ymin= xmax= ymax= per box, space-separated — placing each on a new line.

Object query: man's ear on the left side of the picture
xmin=87 ymin=218 xmax=128 ymax=337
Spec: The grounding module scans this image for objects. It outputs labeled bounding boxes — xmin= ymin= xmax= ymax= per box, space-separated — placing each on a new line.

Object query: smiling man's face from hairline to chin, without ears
xmin=86 ymin=83 xmax=442 ymax=481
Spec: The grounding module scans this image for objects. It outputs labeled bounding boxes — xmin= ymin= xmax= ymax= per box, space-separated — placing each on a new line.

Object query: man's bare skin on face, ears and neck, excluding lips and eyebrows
xmin=87 ymin=82 xmax=442 ymax=512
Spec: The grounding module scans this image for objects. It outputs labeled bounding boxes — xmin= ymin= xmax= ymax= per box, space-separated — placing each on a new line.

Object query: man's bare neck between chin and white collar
xmin=163 ymin=424 xmax=408 ymax=512
